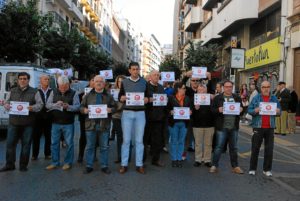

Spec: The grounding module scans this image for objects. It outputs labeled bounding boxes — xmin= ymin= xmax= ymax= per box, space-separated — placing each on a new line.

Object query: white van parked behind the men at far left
xmin=0 ymin=64 xmax=55 ymax=133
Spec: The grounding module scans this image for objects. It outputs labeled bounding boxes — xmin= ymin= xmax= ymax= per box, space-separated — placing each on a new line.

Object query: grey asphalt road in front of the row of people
xmin=0 ymin=124 xmax=300 ymax=201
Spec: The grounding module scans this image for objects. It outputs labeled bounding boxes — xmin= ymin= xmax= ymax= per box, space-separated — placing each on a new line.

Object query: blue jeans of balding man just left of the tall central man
xmin=85 ymin=125 xmax=109 ymax=168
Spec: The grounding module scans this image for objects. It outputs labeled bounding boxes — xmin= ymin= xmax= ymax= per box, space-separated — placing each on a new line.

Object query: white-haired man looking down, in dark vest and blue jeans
xmin=46 ymin=76 xmax=80 ymax=170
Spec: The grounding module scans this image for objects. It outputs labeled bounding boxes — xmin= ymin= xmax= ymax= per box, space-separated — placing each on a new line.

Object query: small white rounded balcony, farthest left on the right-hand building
xmin=184 ymin=6 xmax=203 ymax=32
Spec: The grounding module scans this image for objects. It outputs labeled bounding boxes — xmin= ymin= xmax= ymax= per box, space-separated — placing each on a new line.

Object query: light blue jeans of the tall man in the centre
xmin=121 ymin=110 xmax=146 ymax=167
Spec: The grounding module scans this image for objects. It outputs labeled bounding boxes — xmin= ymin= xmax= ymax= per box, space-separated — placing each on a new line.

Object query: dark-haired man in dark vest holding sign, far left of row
xmin=0 ymin=72 xmax=43 ymax=172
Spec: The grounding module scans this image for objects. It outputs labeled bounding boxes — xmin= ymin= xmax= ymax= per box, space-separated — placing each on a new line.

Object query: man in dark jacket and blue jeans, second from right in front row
xmin=209 ymin=80 xmax=244 ymax=174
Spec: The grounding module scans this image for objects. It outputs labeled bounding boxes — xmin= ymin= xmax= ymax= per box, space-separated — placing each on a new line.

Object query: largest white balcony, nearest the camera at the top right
xmin=213 ymin=0 xmax=259 ymax=35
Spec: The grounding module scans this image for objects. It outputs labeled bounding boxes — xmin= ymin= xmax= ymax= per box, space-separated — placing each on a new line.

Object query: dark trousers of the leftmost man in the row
xmin=6 ymin=125 xmax=33 ymax=167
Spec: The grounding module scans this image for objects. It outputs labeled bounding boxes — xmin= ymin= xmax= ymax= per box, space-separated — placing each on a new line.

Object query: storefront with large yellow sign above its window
xmin=240 ymin=37 xmax=281 ymax=91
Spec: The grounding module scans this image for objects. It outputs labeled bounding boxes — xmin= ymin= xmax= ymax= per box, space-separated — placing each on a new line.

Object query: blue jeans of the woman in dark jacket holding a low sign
xmin=169 ymin=121 xmax=187 ymax=161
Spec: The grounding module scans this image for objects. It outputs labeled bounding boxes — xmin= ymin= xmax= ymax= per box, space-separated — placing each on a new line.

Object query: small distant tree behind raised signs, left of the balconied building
xmin=159 ymin=55 xmax=181 ymax=80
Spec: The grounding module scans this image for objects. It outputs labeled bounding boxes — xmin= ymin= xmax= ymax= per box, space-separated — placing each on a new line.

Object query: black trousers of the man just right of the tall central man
xmin=144 ymin=121 xmax=164 ymax=162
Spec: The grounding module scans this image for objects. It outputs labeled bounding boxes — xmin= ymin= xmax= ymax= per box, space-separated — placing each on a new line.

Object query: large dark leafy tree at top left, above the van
xmin=0 ymin=0 xmax=49 ymax=62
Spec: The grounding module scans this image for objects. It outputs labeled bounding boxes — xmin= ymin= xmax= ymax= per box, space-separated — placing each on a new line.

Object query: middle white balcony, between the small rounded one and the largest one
xmin=201 ymin=9 xmax=221 ymax=45
